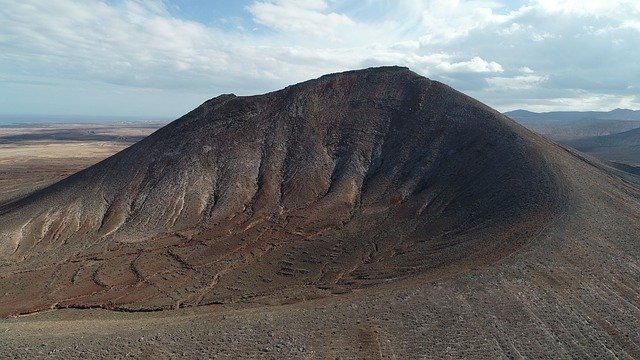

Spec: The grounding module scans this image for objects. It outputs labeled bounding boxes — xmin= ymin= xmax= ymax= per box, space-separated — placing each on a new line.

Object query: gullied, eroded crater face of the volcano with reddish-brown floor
xmin=0 ymin=67 xmax=624 ymax=316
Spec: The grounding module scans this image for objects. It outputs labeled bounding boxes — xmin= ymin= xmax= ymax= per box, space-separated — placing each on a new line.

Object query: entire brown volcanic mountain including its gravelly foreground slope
xmin=0 ymin=67 xmax=640 ymax=358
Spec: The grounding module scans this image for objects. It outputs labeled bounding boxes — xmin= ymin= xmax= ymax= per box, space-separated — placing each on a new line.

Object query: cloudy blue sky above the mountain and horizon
xmin=0 ymin=0 xmax=640 ymax=119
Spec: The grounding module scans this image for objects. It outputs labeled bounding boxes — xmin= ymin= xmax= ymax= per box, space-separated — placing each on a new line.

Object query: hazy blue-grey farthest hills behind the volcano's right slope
xmin=504 ymin=109 xmax=640 ymax=141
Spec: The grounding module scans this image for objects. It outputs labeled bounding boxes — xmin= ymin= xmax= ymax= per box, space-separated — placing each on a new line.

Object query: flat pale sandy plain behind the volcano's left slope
xmin=0 ymin=123 xmax=162 ymax=204
